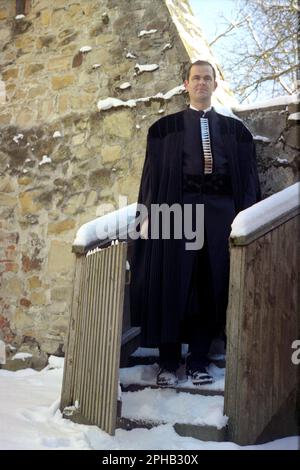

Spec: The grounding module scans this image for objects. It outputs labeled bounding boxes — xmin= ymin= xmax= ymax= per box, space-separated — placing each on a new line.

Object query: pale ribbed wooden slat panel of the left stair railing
xmin=61 ymin=243 xmax=127 ymax=434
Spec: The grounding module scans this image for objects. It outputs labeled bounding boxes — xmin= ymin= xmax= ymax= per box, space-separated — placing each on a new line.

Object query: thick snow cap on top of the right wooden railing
xmin=230 ymin=183 xmax=300 ymax=239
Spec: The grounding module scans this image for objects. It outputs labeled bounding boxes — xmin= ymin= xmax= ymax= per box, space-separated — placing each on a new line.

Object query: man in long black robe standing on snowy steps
xmin=131 ymin=60 xmax=260 ymax=386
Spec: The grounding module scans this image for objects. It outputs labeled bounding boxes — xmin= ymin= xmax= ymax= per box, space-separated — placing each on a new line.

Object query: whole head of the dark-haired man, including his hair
xmin=184 ymin=60 xmax=217 ymax=109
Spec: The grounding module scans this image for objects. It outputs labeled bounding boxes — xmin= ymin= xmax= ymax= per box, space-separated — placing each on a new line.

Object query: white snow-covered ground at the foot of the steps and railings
xmin=0 ymin=358 xmax=299 ymax=450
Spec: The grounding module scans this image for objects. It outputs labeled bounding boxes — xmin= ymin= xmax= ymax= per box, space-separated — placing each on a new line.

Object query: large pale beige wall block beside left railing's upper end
xmin=48 ymin=240 xmax=75 ymax=275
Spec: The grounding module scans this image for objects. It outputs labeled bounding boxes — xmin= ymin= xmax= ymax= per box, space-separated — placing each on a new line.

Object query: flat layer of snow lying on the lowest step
xmin=122 ymin=388 xmax=228 ymax=429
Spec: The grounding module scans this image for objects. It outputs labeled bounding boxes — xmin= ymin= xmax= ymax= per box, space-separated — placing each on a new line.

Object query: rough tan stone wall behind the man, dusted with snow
xmin=0 ymin=0 xmax=295 ymax=360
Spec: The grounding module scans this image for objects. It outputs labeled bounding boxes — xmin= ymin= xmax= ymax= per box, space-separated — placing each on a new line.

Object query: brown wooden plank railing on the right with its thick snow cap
xmin=224 ymin=184 xmax=300 ymax=444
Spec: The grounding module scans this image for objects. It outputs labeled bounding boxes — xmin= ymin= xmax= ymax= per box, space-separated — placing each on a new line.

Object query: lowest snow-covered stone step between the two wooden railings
xmin=117 ymin=384 xmax=227 ymax=442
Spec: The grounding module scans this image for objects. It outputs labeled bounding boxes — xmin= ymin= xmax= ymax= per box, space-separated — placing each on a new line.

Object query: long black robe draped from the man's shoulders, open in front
xmin=130 ymin=110 xmax=260 ymax=347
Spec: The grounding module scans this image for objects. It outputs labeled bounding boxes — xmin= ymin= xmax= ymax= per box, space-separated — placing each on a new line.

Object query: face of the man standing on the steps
xmin=184 ymin=65 xmax=217 ymax=103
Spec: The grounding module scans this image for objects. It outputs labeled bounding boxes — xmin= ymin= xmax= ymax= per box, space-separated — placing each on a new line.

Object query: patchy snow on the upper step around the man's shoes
xmin=120 ymin=364 xmax=225 ymax=391
